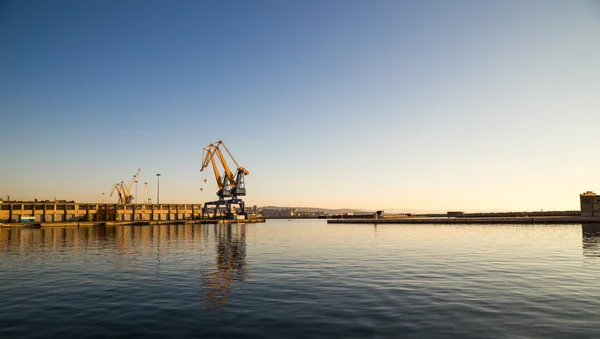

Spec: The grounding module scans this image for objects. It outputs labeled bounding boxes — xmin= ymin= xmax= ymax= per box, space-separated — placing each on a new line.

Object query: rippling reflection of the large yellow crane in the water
xmin=201 ymin=224 xmax=248 ymax=309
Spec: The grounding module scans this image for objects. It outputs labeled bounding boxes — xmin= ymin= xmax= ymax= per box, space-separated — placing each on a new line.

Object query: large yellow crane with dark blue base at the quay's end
xmin=200 ymin=140 xmax=250 ymax=217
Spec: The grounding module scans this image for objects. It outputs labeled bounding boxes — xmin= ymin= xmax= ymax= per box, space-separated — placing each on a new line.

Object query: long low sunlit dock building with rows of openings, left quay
xmin=0 ymin=202 xmax=202 ymax=222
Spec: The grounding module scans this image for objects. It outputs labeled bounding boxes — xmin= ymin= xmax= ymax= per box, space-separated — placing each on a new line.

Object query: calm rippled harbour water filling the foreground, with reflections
xmin=0 ymin=220 xmax=600 ymax=338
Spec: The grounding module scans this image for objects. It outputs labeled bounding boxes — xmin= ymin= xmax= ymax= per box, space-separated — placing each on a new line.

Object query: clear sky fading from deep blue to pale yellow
xmin=0 ymin=0 xmax=600 ymax=212
